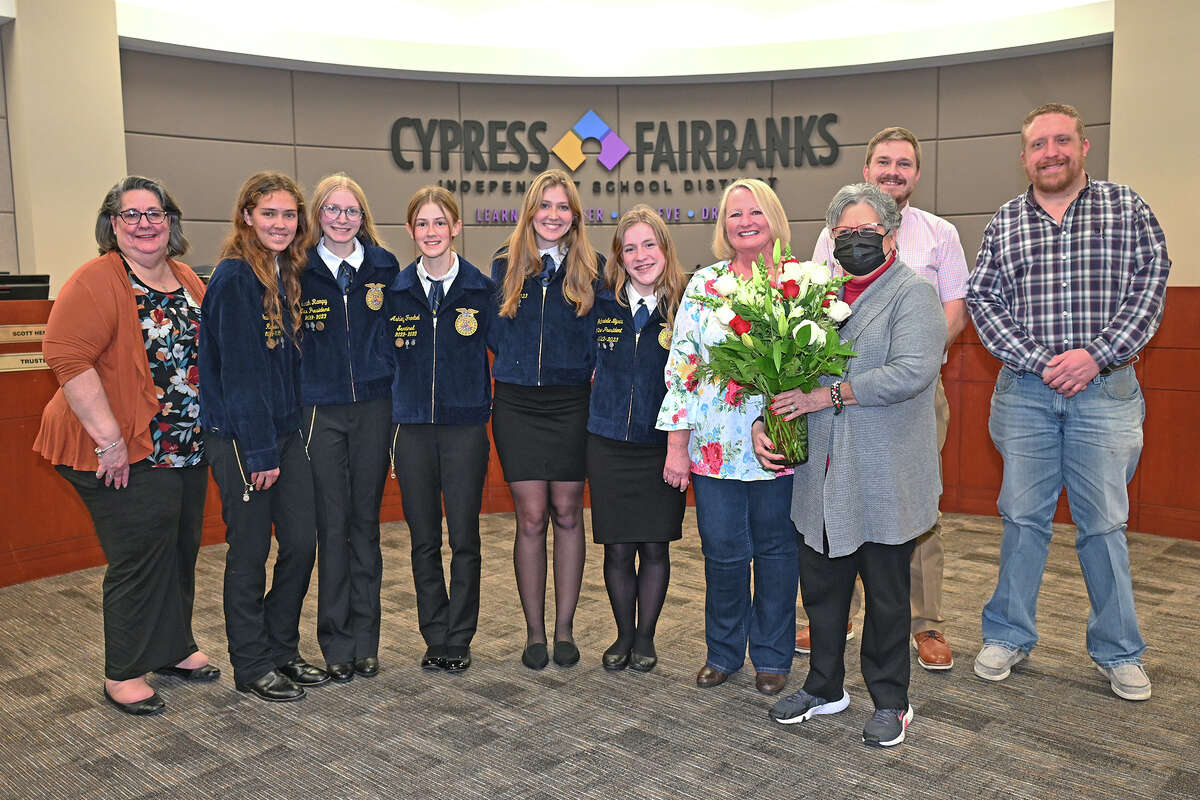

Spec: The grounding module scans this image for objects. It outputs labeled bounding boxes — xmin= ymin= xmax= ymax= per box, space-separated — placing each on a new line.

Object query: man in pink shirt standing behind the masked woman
xmin=796 ymin=127 xmax=968 ymax=669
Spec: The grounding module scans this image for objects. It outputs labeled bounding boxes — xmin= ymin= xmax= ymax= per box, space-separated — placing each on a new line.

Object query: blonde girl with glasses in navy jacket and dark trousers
xmin=300 ymin=174 xmax=400 ymax=682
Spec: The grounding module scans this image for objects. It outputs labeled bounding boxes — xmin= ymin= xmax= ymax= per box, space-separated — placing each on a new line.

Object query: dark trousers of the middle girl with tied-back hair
xmin=392 ymin=425 xmax=490 ymax=648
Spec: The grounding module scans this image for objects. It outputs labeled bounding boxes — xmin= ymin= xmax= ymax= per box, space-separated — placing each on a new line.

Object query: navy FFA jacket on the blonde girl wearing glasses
xmin=300 ymin=242 xmax=400 ymax=405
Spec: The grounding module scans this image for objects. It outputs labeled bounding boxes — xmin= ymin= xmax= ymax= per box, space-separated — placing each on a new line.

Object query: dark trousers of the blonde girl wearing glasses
xmin=304 ymin=397 xmax=391 ymax=664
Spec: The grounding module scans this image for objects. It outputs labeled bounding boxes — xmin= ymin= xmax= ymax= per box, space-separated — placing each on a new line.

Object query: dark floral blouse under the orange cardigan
xmin=126 ymin=266 xmax=204 ymax=467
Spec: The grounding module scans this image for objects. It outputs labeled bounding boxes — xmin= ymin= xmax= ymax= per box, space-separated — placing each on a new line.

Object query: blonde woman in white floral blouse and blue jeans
xmin=658 ymin=179 xmax=801 ymax=694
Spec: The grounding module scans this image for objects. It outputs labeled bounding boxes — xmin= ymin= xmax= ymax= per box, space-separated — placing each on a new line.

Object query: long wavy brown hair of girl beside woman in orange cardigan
xmin=221 ymin=173 xmax=308 ymax=344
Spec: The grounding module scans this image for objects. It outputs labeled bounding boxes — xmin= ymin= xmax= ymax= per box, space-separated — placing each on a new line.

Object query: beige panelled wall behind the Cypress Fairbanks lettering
xmin=121 ymin=47 xmax=1111 ymax=275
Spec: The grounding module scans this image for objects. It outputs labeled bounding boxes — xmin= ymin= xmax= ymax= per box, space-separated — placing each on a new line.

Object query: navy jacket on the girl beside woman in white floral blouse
xmin=588 ymin=289 xmax=671 ymax=446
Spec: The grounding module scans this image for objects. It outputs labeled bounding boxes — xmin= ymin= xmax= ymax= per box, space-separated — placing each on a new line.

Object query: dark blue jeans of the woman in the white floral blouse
xmin=691 ymin=475 xmax=799 ymax=674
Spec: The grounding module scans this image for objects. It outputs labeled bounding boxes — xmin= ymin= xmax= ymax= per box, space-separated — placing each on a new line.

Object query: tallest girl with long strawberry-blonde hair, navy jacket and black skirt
xmin=492 ymin=169 xmax=604 ymax=669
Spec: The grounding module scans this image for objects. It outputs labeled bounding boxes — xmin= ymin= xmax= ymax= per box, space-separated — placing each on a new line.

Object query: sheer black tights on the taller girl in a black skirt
xmin=509 ymin=481 xmax=586 ymax=642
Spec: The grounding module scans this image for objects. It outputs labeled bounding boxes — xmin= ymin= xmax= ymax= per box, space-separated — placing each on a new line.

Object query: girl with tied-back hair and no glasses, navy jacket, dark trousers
xmin=385 ymin=186 xmax=496 ymax=672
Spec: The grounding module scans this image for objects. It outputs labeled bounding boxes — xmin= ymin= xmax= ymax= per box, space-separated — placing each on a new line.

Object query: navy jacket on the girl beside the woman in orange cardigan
xmin=197 ymin=258 xmax=300 ymax=473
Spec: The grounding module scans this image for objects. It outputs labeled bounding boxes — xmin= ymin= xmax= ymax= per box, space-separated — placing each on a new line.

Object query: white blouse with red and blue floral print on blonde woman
xmin=656 ymin=261 xmax=775 ymax=481
